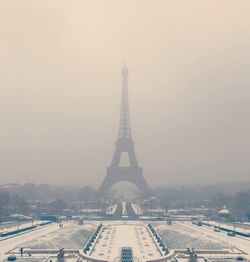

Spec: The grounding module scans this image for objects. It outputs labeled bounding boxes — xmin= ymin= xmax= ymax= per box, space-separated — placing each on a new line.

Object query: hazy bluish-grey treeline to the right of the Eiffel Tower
xmin=153 ymin=183 xmax=250 ymax=219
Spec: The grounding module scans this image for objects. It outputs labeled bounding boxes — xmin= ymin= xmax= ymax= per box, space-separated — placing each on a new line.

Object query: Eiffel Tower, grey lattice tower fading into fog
xmin=99 ymin=65 xmax=150 ymax=198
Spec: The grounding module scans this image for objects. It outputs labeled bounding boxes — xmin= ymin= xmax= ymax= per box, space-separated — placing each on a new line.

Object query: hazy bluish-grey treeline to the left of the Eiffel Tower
xmin=0 ymin=183 xmax=95 ymax=220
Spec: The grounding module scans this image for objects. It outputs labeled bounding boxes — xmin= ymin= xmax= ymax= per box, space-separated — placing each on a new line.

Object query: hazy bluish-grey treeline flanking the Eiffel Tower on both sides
xmin=0 ymin=183 xmax=250 ymax=218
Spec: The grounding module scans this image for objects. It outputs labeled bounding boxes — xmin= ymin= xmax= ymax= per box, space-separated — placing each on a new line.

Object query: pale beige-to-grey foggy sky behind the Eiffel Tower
xmin=0 ymin=0 xmax=250 ymax=187
